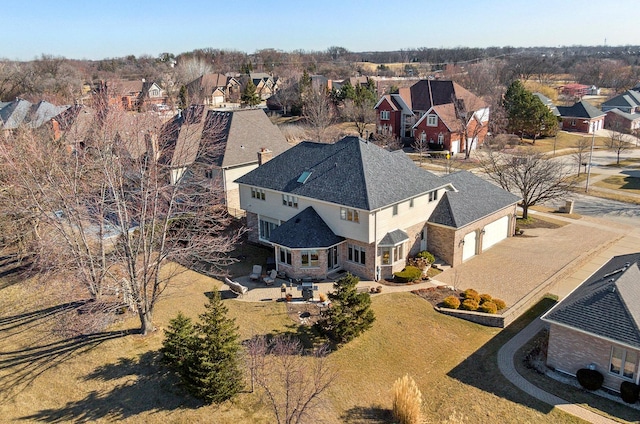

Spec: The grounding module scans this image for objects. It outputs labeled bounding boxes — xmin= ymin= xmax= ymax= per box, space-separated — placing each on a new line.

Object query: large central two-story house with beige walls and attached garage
xmin=236 ymin=137 xmax=520 ymax=280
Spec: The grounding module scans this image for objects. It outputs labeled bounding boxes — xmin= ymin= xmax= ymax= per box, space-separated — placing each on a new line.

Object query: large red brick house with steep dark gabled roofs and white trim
xmin=375 ymin=80 xmax=489 ymax=153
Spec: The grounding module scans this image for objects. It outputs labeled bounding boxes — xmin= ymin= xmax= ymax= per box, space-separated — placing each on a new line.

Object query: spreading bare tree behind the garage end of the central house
xmin=478 ymin=148 xmax=575 ymax=219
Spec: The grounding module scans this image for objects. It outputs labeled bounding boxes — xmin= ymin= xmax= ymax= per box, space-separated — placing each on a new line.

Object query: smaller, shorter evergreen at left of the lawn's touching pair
xmin=160 ymin=312 xmax=197 ymax=377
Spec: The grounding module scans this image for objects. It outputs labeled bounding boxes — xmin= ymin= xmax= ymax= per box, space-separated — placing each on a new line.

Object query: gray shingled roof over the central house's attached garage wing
xmin=429 ymin=171 xmax=521 ymax=228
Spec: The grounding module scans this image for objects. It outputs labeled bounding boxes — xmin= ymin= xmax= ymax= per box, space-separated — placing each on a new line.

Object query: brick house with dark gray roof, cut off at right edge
xmin=542 ymin=253 xmax=640 ymax=391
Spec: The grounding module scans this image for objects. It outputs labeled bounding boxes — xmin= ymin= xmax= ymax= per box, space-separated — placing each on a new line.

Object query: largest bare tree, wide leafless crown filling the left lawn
xmin=0 ymin=106 xmax=240 ymax=334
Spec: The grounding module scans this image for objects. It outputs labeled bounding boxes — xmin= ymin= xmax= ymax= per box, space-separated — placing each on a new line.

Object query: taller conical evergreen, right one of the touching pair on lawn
xmin=185 ymin=290 xmax=242 ymax=403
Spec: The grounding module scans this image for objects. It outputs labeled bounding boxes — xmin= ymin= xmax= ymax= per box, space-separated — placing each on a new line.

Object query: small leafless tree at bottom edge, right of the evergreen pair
xmin=247 ymin=336 xmax=337 ymax=424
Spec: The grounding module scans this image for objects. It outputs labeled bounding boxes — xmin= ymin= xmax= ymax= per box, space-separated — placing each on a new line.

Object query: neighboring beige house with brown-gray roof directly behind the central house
xmin=163 ymin=105 xmax=290 ymax=215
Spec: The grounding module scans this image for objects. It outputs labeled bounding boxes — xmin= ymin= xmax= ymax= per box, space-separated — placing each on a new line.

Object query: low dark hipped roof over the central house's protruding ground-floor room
xmin=269 ymin=206 xmax=344 ymax=249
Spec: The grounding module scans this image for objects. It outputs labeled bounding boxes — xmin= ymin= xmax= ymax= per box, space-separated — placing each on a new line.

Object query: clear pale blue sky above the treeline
xmin=0 ymin=0 xmax=640 ymax=60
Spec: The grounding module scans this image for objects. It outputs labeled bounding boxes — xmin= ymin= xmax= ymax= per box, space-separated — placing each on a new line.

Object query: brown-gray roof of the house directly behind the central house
xmin=162 ymin=105 xmax=289 ymax=168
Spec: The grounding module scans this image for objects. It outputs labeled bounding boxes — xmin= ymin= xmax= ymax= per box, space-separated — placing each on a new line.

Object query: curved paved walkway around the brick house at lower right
xmin=498 ymin=318 xmax=617 ymax=424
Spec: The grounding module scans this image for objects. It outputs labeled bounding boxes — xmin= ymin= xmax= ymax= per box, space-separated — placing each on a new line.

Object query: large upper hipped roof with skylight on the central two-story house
xmin=236 ymin=137 xmax=446 ymax=211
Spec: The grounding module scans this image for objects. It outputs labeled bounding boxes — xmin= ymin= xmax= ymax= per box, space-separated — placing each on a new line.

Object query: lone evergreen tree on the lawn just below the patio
xmin=317 ymin=274 xmax=375 ymax=344
